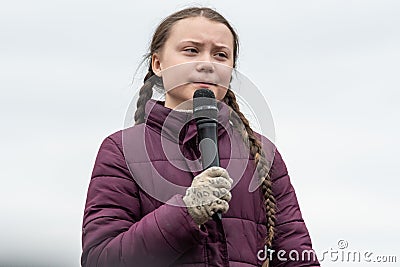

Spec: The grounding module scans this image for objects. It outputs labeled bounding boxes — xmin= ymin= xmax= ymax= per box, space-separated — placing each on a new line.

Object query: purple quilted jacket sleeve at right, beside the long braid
xmin=270 ymin=150 xmax=320 ymax=267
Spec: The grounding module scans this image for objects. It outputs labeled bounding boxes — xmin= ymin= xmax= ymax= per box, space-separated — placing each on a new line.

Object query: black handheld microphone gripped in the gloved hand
xmin=193 ymin=88 xmax=222 ymax=221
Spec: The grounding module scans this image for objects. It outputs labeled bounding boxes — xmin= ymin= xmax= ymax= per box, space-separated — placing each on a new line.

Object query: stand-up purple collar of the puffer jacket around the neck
xmin=145 ymin=99 xmax=230 ymax=144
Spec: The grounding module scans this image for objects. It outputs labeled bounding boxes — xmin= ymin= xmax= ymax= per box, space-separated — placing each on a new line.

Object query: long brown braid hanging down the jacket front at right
xmin=223 ymin=89 xmax=276 ymax=248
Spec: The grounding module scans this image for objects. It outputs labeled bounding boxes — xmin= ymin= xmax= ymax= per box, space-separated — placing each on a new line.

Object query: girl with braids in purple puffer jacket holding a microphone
xmin=81 ymin=8 xmax=319 ymax=266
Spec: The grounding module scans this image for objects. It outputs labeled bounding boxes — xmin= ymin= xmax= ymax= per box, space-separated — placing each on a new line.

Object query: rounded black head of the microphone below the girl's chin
xmin=193 ymin=88 xmax=218 ymax=120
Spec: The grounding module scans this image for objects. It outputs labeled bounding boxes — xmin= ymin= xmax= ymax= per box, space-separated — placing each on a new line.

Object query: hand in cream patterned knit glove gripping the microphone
xmin=183 ymin=167 xmax=233 ymax=225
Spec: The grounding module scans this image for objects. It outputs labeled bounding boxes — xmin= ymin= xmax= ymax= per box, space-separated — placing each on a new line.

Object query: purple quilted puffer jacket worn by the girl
xmin=81 ymin=100 xmax=319 ymax=267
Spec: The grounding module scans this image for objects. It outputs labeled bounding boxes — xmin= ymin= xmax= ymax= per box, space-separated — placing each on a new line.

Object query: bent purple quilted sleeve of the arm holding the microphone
xmin=81 ymin=137 xmax=206 ymax=266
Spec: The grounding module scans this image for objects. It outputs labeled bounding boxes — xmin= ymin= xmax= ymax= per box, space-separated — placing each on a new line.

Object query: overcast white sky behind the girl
xmin=0 ymin=0 xmax=400 ymax=266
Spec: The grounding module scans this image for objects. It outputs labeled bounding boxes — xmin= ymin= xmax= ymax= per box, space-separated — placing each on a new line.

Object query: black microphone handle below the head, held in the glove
xmin=197 ymin=119 xmax=222 ymax=221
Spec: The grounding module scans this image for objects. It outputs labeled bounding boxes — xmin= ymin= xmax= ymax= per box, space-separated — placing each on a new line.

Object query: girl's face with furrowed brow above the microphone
xmin=152 ymin=17 xmax=234 ymax=109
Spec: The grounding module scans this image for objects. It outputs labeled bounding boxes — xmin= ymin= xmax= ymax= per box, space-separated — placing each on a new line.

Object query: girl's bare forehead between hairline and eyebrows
xmin=167 ymin=17 xmax=233 ymax=48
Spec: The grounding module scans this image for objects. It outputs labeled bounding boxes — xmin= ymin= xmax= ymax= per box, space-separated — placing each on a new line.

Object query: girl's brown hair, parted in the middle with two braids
xmin=135 ymin=7 xmax=275 ymax=266
